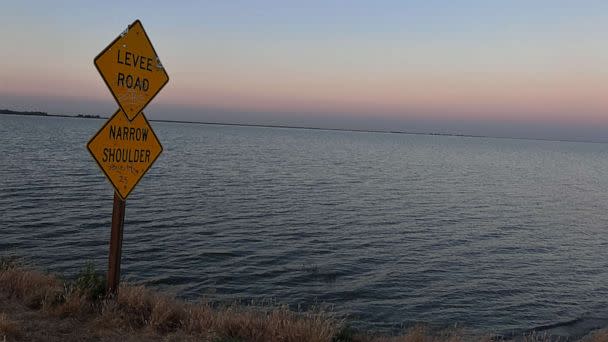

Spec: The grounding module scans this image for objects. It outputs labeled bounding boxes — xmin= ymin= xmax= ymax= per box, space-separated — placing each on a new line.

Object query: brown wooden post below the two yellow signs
xmin=107 ymin=192 xmax=127 ymax=295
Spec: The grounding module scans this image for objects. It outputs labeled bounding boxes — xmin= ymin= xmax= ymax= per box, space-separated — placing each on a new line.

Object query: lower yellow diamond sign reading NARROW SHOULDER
xmin=87 ymin=110 xmax=163 ymax=199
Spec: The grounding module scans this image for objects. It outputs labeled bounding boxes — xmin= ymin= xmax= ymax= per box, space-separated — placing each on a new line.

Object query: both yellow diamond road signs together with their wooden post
xmin=87 ymin=20 xmax=169 ymax=295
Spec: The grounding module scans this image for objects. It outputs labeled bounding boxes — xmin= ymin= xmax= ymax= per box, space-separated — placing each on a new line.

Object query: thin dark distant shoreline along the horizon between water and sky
xmin=0 ymin=109 xmax=608 ymax=144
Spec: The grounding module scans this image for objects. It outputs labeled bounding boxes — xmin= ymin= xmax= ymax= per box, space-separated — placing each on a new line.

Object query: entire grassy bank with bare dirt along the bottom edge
xmin=0 ymin=260 xmax=608 ymax=342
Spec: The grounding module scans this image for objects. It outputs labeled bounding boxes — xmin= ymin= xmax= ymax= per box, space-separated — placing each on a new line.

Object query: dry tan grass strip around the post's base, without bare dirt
xmin=0 ymin=260 xmax=341 ymax=342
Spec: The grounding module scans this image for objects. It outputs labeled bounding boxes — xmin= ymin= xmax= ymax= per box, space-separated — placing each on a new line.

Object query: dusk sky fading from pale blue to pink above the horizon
xmin=0 ymin=0 xmax=608 ymax=141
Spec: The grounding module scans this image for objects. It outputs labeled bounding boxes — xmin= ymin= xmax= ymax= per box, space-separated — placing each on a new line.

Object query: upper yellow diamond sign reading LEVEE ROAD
xmin=95 ymin=20 xmax=169 ymax=120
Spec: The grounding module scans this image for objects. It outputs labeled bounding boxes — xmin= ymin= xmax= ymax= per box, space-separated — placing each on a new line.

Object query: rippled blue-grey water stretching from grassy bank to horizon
xmin=0 ymin=115 xmax=608 ymax=334
